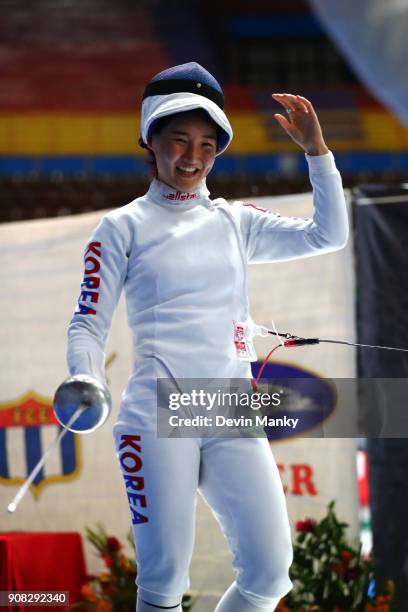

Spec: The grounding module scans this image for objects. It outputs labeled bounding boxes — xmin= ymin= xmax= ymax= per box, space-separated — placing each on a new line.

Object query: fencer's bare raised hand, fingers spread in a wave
xmin=272 ymin=94 xmax=329 ymax=155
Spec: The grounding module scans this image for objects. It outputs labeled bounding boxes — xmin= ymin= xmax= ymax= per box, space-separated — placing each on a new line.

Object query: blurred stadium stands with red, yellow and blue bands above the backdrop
xmin=0 ymin=0 xmax=408 ymax=222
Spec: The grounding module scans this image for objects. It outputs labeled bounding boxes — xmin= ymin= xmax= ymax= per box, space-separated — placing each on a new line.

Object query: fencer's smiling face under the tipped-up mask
xmin=149 ymin=111 xmax=217 ymax=191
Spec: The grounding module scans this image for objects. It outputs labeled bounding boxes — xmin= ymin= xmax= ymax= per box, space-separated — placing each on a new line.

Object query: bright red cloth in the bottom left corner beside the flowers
xmin=0 ymin=532 xmax=87 ymax=612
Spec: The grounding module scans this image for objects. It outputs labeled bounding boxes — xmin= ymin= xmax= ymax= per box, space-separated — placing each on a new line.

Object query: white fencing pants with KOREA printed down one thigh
xmin=114 ymin=423 xmax=292 ymax=610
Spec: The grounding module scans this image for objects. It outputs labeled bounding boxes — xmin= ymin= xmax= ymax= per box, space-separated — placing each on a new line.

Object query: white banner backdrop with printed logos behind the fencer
xmin=0 ymin=194 xmax=357 ymax=612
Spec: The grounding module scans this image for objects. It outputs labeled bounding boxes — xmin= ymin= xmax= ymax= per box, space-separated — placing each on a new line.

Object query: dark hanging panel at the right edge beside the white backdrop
xmin=353 ymin=185 xmax=408 ymax=610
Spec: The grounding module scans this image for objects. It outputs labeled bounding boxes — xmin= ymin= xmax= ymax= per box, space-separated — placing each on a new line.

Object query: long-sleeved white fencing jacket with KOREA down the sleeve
xmin=68 ymin=153 xmax=348 ymax=404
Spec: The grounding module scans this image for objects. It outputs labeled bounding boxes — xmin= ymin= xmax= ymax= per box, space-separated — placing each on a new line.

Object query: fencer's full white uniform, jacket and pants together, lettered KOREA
xmin=68 ymin=153 xmax=348 ymax=610
